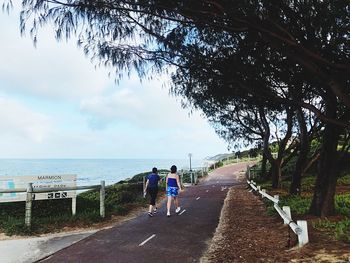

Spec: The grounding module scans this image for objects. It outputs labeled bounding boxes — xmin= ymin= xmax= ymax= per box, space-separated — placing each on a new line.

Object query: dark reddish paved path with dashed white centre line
xmin=40 ymin=163 xmax=246 ymax=263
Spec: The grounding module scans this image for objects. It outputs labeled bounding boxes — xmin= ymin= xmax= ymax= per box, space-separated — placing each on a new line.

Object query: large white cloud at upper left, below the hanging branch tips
xmin=0 ymin=11 xmax=113 ymax=100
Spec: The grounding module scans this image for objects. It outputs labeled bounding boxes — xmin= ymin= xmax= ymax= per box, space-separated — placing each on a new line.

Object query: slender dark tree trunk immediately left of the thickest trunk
xmin=289 ymin=108 xmax=309 ymax=195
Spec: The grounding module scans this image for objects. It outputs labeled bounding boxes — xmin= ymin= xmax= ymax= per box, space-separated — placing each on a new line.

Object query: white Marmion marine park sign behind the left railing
xmin=0 ymin=174 xmax=77 ymax=203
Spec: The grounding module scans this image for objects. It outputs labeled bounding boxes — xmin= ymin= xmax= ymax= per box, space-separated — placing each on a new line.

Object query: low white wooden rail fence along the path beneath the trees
xmin=247 ymin=177 xmax=309 ymax=247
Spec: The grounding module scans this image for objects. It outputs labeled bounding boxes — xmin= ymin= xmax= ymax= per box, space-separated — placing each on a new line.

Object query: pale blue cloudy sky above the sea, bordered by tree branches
xmin=0 ymin=7 xmax=228 ymax=159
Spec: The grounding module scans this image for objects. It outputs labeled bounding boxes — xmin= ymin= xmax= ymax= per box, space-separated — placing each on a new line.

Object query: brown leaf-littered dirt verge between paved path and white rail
xmin=201 ymin=186 xmax=350 ymax=263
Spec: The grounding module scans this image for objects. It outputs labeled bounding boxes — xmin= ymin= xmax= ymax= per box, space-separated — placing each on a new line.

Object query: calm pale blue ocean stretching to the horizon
xmin=0 ymin=159 xmax=204 ymax=186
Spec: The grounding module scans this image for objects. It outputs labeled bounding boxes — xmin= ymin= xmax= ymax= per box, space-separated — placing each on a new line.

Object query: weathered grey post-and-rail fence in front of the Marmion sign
xmin=0 ymin=181 xmax=106 ymax=227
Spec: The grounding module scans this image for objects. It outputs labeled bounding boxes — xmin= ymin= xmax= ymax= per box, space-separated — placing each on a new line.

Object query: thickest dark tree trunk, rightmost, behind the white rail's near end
xmin=309 ymin=96 xmax=341 ymax=217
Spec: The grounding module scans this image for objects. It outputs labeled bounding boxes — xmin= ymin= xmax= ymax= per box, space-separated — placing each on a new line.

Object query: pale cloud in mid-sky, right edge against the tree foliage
xmin=80 ymin=75 xmax=204 ymax=129
